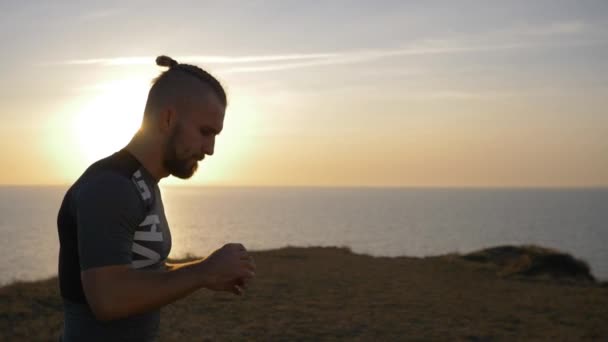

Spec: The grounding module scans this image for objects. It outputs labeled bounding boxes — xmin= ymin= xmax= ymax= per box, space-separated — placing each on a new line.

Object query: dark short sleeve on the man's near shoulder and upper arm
xmin=76 ymin=172 xmax=144 ymax=271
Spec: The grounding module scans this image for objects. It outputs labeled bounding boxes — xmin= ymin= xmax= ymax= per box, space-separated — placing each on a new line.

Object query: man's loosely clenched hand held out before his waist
xmin=197 ymin=243 xmax=255 ymax=295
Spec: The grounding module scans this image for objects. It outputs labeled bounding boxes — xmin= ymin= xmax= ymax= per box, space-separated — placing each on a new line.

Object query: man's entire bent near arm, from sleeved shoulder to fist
xmin=76 ymin=173 xmax=255 ymax=320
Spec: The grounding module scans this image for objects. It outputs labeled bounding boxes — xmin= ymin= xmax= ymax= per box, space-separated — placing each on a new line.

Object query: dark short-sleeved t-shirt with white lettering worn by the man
xmin=57 ymin=149 xmax=171 ymax=341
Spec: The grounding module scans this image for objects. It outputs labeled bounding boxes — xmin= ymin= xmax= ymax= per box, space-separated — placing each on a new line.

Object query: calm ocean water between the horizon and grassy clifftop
xmin=0 ymin=187 xmax=608 ymax=285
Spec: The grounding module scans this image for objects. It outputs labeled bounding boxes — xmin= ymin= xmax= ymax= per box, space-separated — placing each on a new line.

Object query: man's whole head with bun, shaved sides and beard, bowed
xmin=141 ymin=56 xmax=227 ymax=178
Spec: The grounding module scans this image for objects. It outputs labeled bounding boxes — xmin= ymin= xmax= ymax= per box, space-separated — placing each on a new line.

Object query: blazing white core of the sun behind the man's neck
xmin=73 ymin=80 xmax=148 ymax=164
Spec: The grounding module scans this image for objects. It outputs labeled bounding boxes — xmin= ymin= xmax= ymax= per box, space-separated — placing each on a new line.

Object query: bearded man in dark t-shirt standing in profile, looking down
xmin=57 ymin=56 xmax=255 ymax=341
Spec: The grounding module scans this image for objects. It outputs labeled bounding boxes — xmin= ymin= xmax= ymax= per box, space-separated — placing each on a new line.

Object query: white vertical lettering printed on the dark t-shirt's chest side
xmin=131 ymin=170 xmax=163 ymax=269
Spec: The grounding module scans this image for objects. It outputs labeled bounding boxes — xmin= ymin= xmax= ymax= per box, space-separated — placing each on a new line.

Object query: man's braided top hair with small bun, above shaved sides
xmin=150 ymin=56 xmax=228 ymax=107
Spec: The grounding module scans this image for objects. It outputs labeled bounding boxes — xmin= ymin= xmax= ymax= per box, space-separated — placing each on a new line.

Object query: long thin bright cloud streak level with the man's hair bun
xmin=44 ymin=21 xmax=608 ymax=73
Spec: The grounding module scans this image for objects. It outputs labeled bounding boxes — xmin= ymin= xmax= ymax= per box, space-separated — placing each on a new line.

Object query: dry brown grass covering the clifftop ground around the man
xmin=0 ymin=248 xmax=608 ymax=341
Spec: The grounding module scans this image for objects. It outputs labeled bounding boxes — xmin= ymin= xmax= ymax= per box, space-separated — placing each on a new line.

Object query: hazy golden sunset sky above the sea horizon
xmin=0 ymin=0 xmax=608 ymax=187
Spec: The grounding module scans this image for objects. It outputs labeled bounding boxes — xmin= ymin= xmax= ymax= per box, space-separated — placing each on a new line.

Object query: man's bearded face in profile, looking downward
xmin=163 ymin=92 xmax=225 ymax=179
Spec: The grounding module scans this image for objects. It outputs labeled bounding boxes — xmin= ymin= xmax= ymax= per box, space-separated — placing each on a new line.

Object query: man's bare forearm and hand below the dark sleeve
xmin=81 ymin=244 xmax=255 ymax=320
